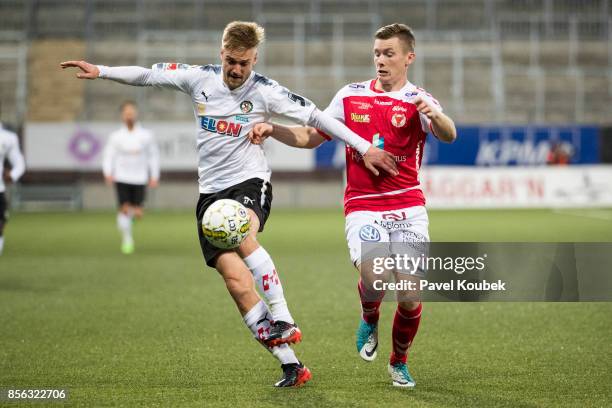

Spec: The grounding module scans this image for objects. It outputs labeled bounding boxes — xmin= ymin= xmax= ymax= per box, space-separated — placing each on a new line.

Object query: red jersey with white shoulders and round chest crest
xmin=325 ymin=80 xmax=442 ymax=215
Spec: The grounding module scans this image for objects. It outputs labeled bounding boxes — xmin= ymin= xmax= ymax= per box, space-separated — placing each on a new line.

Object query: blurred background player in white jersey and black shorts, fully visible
xmin=102 ymin=101 xmax=159 ymax=254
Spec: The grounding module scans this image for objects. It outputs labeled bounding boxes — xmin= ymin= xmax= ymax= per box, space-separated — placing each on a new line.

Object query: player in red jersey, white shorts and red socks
xmin=251 ymin=24 xmax=456 ymax=387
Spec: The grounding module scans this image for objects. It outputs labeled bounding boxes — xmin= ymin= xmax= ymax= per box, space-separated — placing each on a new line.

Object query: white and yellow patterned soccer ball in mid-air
xmin=202 ymin=199 xmax=251 ymax=249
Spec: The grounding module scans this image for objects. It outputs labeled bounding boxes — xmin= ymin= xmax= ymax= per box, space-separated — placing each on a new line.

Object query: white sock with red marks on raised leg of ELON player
xmin=244 ymin=247 xmax=294 ymax=324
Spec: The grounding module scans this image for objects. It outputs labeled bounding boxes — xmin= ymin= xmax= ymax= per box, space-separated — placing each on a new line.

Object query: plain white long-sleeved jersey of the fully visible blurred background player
xmin=102 ymin=124 xmax=159 ymax=184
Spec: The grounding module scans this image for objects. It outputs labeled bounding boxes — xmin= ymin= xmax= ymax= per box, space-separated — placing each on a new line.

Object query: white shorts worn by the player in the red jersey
xmin=346 ymin=206 xmax=429 ymax=267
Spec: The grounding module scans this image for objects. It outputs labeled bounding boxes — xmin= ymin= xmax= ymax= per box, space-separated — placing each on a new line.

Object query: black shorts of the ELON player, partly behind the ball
xmin=196 ymin=178 xmax=272 ymax=268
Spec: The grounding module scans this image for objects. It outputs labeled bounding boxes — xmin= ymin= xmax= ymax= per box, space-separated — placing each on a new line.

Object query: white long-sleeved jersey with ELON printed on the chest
xmin=98 ymin=63 xmax=370 ymax=193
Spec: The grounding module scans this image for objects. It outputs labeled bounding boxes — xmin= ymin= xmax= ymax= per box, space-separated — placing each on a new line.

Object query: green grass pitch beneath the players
xmin=0 ymin=210 xmax=612 ymax=407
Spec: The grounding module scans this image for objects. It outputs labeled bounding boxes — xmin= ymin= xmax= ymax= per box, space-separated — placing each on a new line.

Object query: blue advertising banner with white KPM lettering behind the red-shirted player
xmin=316 ymin=126 xmax=600 ymax=168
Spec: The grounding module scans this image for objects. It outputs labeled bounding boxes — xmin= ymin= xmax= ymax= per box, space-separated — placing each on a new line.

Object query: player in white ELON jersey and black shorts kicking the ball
xmin=61 ymin=22 xmax=397 ymax=387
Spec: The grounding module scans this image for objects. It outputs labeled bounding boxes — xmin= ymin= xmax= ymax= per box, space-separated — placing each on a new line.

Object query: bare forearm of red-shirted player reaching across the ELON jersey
xmin=247 ymin=123 xmax=325 ymax=149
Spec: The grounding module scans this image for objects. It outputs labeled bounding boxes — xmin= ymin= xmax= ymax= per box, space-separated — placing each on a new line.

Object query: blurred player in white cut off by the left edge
xmin=0 ymin=123 xmax=25 ymax=255
